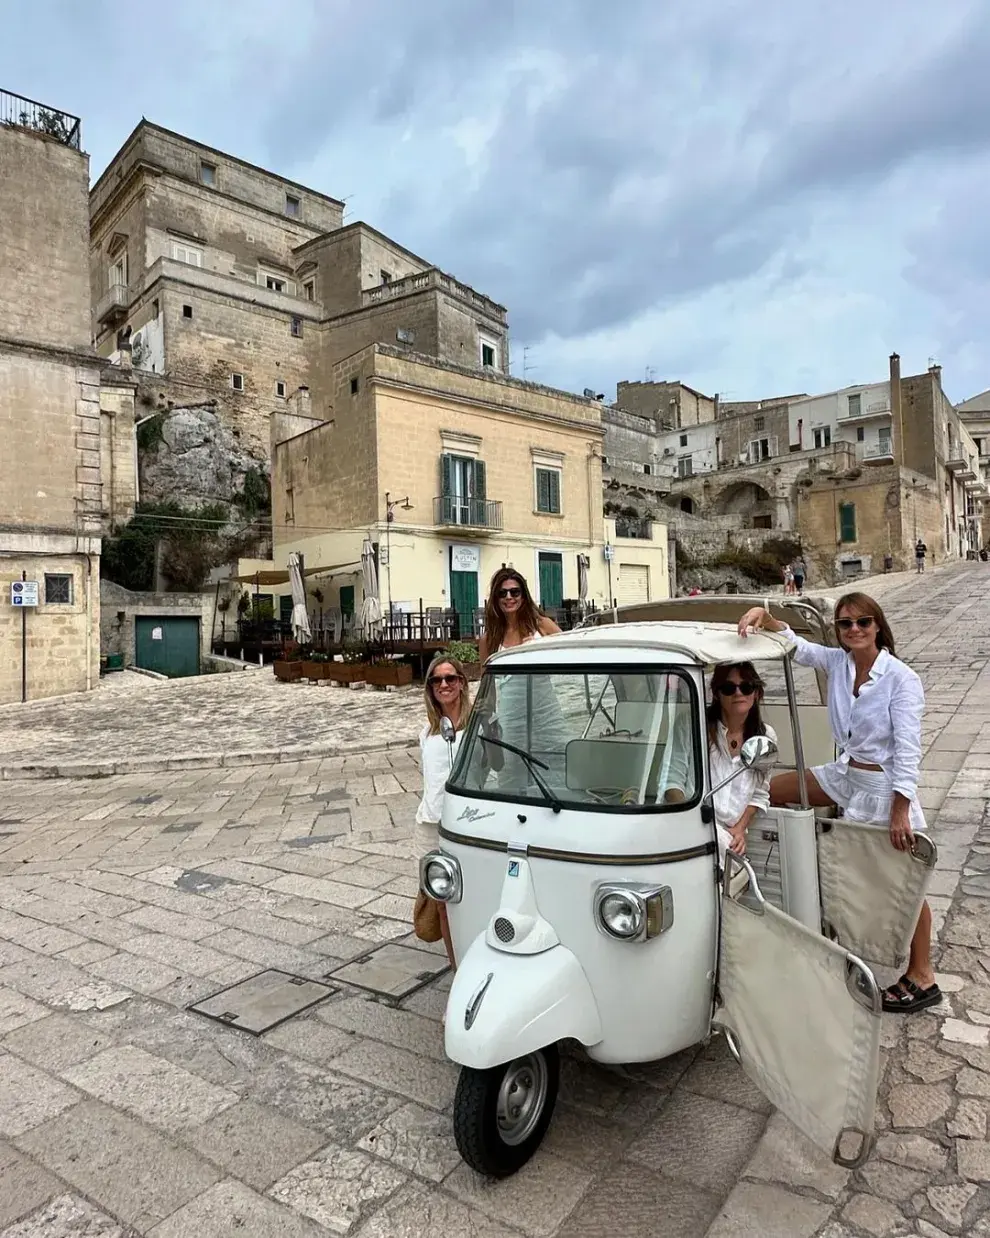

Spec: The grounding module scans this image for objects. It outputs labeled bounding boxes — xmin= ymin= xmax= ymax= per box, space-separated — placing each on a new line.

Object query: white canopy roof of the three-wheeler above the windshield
xmin=488 ymin=620 xmax=794 ymax=669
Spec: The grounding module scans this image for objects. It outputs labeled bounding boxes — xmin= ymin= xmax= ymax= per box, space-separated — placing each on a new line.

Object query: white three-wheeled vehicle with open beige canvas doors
xmin=420 ymin=598 xmax=934 ymax=1176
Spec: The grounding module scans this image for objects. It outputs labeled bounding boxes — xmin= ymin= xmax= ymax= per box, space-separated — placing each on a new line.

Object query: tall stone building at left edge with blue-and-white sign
xmin=0 ymin=92 xmax=103 ymax=703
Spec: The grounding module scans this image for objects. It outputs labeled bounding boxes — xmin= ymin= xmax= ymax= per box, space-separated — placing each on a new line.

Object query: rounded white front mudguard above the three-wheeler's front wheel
xmin=444 ymin=933 xmax=601 ymax=1070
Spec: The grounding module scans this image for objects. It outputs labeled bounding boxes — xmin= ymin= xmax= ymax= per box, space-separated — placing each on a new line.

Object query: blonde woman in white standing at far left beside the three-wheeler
xmin=415 ymin=652 xmax=471 ymax=968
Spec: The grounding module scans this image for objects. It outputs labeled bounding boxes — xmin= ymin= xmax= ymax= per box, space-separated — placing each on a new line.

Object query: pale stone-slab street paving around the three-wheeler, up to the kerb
xmin=0 ymin=565 xmax=990 ymax=1238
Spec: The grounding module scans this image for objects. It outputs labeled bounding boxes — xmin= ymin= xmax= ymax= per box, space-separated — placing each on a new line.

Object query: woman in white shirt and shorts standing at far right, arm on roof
xmin=739 ymin=593 xmax=942 ymax=1011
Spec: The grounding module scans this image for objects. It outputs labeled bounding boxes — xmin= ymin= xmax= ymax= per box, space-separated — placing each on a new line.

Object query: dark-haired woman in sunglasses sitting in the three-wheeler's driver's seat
xmin=663 ymin=662 xmax=777 ymax=864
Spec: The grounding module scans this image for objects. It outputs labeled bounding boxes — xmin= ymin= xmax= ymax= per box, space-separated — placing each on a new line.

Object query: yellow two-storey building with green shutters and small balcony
xmin=272 ymin=344 xmax=669 ymax=634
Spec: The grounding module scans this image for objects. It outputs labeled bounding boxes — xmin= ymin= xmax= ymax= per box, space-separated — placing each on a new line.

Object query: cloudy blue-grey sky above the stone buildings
xmin=0 ymin=0 xmax=990 ymax=400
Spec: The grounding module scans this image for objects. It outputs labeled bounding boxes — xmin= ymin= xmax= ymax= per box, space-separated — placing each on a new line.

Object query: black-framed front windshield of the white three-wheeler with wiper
xmin=448 ymin=666 xmax=702 ymax=812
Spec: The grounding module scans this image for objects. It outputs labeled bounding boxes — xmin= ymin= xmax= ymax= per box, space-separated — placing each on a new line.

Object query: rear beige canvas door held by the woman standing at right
xmin=818 ymin=820 xmax=937 ymax=969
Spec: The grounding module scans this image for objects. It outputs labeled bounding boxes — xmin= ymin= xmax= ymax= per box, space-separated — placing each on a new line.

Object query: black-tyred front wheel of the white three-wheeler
xmin=454 ymin=1045 xmax=561 ymax=1177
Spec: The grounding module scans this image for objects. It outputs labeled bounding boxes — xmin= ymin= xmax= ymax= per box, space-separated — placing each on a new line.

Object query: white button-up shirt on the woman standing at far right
xmin=785 ymin=628 xmax=924 ymax=800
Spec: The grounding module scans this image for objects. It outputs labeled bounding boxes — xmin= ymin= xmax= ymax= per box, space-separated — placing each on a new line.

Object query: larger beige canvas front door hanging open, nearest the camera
xmin=715 ymin=893 xmax=880 ymax=1155
